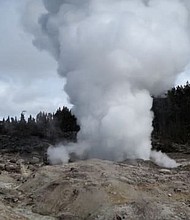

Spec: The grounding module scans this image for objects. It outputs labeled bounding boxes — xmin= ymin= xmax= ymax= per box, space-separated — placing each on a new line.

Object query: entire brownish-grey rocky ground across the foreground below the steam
xmin=0 ymin=135 xmax=190 ymax=220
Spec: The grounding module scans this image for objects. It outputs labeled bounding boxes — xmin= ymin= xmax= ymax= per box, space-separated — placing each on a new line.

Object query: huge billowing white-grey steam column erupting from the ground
xmin=25 ymin=0 xmax=190 ymax=167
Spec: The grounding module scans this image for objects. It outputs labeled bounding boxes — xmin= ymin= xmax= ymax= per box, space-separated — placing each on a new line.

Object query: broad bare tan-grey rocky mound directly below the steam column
xmin=20 ymin=157 xmax=190 ymax=220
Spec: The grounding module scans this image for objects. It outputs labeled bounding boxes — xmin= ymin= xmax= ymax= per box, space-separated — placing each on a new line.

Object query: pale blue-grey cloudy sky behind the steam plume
xmin=0 ymin=0 xmax=190 ymax=118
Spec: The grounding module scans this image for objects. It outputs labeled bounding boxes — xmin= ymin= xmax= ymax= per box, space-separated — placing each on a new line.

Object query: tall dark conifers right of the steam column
xmin=152 ymin=82 xmax=190 ymax=144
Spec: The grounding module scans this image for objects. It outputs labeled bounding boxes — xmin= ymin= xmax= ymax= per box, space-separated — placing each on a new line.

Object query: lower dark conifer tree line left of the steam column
xmin=0 ymin=107 xmax=80 ymax=140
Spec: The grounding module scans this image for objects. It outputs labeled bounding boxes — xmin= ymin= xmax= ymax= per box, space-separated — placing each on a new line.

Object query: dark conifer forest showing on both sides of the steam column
xmin=0 ymin=82 xmax=190 ymax=144
